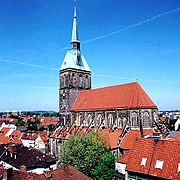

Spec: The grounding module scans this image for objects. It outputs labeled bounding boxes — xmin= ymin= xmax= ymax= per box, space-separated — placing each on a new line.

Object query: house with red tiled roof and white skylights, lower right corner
xmin=115 ymin=138 xmax=180 ymax=180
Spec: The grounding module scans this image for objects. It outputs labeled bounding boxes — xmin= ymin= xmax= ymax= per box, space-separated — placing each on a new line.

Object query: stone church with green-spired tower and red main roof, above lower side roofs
xmin=59 ymin=4 xmax=158 ymax=129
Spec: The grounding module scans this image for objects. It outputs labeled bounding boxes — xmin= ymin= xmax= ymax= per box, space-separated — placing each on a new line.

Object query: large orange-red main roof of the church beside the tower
xmin=72 ymin=82 xmax=157 ymax=111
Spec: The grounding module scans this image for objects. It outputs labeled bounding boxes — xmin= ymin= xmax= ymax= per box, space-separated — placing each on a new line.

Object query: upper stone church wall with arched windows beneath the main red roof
xmin=71 ymin=109 xmax=158 ymax=129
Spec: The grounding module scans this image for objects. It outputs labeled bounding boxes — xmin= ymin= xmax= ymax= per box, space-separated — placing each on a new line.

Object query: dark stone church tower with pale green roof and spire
xmin=59 ymin=1 xmax=91 ymax=125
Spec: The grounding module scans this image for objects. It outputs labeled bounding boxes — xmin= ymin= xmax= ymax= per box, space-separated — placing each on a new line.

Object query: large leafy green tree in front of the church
xmin=59 ymin=132 xmax=115 ymax=180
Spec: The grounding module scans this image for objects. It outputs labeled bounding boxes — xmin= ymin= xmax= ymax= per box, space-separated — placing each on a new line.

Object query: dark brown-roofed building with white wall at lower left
xmin=0 ymin=144 xmax=57 ymax=174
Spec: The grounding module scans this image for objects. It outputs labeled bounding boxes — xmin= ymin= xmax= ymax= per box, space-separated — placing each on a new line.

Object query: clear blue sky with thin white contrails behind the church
xmin=0 ymin=0 xmax=180 ymax=111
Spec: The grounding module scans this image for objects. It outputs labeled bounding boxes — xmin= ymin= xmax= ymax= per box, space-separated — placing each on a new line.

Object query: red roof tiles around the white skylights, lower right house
xmin=118 ymin=138 xmax=180 ymax=180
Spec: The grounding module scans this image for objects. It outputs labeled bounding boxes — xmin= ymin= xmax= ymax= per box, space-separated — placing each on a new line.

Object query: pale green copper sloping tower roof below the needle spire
xmin=60 ymin=48 xmax=91 ymax=71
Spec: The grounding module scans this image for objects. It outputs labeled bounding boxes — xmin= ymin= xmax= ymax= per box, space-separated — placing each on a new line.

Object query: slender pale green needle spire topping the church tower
xmin=71 ymin=0 xmax=80 ymax=50
